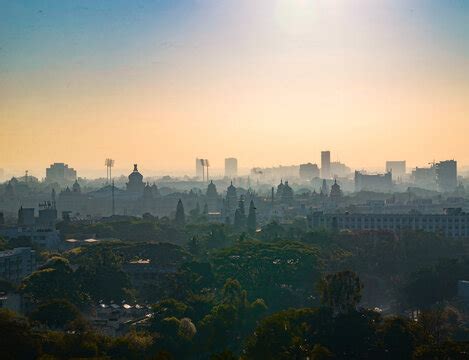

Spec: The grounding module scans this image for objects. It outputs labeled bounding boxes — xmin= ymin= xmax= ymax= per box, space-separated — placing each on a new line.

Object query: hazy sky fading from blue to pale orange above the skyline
xmin=0 ymin=0 xmax=469 ymax=176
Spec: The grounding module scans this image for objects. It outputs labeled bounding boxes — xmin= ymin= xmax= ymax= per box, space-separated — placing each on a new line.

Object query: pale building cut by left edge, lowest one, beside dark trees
xmin=0 ymin=247 xmax=36 ymax=284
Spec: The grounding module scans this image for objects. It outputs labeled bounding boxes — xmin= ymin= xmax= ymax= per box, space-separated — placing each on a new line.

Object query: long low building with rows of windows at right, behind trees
xmin=309 ymin=209 xmax=469 ymax=238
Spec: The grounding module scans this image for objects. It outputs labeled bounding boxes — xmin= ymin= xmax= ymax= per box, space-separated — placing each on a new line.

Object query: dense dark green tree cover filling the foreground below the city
xmin=0 ymin=217 xmax=469 ymax=359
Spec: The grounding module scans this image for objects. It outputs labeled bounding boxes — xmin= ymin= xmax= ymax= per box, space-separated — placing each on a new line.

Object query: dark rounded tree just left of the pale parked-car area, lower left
xmin=30 ymin=299 xmax=81 ymax=329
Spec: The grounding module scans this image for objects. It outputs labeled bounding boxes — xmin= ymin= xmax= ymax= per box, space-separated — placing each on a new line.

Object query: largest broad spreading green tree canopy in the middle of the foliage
xmin=210 ymin=240 xmax=322 ymax=311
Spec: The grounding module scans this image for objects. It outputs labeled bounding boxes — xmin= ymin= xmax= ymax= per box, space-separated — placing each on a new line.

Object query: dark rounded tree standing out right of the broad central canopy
xmin=319 ymin=270 xmax=363 ymax=314
